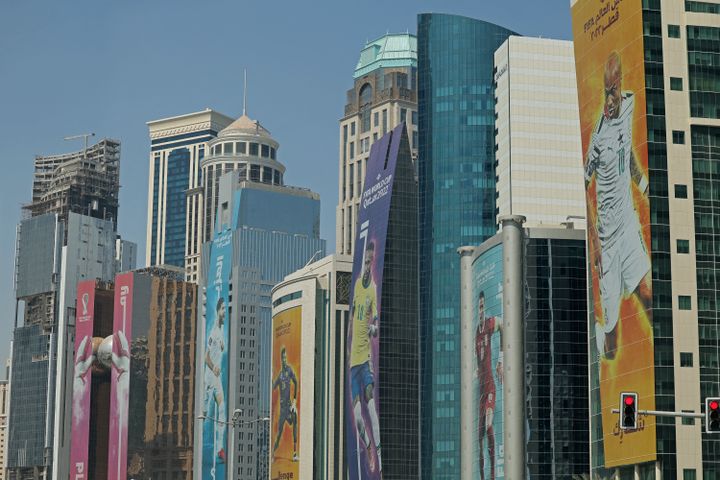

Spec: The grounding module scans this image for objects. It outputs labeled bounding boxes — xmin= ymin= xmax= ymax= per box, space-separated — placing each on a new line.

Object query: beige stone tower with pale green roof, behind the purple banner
xmin=335 ymin=33 xmax=418 ymax=255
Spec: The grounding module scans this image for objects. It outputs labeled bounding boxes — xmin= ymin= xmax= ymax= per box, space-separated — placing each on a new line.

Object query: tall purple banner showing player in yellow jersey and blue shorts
xmin=345 ymin=123 xmax=405 ymax=480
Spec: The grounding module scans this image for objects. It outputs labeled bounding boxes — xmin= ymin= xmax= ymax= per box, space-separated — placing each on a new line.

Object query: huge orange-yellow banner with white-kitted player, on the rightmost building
xmin=572 ymin=0 xmax=656 ymax=468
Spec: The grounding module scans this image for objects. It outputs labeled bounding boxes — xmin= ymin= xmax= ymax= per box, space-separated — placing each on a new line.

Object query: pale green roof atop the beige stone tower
xmin=353 ymin=33 xmax=417 ymax=78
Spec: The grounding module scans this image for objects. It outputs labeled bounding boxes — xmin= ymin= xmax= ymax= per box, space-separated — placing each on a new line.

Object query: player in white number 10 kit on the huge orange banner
xmin=585 ymin=52 xmax=652 ymax=359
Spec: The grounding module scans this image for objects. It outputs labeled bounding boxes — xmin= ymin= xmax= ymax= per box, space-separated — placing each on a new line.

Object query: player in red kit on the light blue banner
xmin=475 ymin=292 xmax=503 ymax=480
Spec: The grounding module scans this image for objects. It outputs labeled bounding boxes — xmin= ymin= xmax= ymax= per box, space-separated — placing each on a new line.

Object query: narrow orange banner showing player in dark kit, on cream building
xmin=270 ymin=307 xmax=302 ymax=480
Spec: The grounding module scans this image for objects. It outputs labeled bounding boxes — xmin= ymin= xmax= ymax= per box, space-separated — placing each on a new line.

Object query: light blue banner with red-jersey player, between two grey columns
xmin=472 ymin=244 xmax=505 ymax=480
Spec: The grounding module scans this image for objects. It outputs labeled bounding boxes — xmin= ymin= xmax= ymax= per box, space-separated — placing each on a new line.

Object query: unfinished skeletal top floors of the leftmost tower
xmin=23 ymin=138 xmax=120 ymax=224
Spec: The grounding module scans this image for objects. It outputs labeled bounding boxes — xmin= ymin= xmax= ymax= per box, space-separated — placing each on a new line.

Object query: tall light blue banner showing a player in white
xmin=201 ymin=230 xmax=233 ymax=480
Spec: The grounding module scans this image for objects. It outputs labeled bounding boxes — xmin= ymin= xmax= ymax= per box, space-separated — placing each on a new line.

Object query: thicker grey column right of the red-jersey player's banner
xmin=500 ymin=215 xmax=525 ymax=480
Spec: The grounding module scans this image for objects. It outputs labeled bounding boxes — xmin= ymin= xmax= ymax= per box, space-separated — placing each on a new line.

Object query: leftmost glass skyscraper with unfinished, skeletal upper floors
xmin=7 ymin=139 xmax=134 ymax=479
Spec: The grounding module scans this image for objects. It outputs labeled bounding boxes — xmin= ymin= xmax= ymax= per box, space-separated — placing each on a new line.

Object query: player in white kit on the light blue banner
xmin=203 ymin=297 xmax=227 ymax=463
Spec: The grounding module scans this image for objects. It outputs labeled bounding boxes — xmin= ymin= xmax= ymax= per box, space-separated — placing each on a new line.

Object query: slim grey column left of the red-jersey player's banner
xmin=458 ymin=247 xmax=477 ymax=478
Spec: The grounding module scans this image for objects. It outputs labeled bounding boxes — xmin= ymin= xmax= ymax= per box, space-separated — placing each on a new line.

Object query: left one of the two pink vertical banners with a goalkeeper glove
xmin=70 ymin=280 xmax=95 ymax=480
